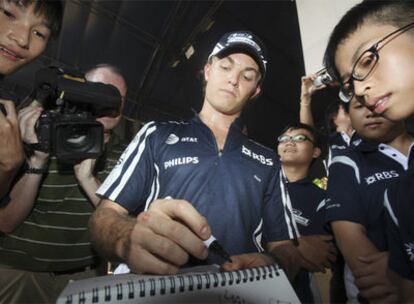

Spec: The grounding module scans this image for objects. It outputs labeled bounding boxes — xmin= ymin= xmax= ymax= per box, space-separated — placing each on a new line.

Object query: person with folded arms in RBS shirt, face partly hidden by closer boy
xmin=326 ymin=98 xmax=413 ymax=301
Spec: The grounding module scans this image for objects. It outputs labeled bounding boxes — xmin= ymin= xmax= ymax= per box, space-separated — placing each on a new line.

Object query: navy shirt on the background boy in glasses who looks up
xmin=287 ymin=177 xmax=326 ymax=303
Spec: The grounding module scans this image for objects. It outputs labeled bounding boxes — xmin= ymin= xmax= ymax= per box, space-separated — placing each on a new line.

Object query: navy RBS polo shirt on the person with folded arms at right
xmin=326 ymin=141 xmax=408 ymax=251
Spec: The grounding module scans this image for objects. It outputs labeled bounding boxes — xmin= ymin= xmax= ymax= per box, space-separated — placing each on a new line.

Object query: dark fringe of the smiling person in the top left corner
xmin=6 ymin=0 xmax=63 ymax=39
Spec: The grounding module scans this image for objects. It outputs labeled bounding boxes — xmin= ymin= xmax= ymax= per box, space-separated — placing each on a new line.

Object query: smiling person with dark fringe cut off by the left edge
xmin=0 ymin=0 xmax=63 ymax=200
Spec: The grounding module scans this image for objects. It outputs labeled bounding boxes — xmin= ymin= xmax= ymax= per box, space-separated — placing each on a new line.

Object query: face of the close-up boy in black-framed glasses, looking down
xmin=335 ymin=22 xmax=414 ymax=121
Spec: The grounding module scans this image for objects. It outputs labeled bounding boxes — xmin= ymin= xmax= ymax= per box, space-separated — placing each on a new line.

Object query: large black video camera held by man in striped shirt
xmin=31 ymin=67 xmax=121 ymax=163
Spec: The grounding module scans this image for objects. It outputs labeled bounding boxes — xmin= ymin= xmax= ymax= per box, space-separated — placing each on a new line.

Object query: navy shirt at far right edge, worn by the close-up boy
xmin=384 ymin=166 xmax=414 ymax=280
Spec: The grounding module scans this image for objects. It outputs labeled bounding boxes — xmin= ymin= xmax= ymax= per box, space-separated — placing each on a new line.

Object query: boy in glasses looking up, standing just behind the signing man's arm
xmin=277 ymin=123 xmax=336 ymax=303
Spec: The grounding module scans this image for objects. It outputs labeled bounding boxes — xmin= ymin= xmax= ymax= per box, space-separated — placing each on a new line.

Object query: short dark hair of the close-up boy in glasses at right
xmin=323 ymin=0 xmax=414 ymax=81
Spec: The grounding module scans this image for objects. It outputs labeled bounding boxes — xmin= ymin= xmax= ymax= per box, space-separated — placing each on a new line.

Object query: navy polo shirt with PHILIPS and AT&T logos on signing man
xmin=97 ymin=115 xmax=290 ymax=263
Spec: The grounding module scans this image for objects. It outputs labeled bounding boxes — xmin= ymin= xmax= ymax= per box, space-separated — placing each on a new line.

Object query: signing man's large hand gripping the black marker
xmin=123 ymin=199 xmax=211 ymax=274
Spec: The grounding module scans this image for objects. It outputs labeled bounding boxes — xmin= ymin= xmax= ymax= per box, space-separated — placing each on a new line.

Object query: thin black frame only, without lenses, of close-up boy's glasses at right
xmin=339 ymin=22 xmax=414 ymax=102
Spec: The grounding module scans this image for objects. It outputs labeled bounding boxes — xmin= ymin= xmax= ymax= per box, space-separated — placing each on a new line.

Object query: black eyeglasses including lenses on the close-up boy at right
xmin=339 ymin=22 xmax=414 ymax=102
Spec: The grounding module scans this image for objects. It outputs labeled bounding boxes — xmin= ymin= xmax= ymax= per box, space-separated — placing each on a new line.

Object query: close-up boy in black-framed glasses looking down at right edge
xmin=324 ymin=1 xmax=414 ymax=302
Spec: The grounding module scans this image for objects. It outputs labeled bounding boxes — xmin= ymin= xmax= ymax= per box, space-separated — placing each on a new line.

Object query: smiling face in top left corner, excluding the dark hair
xmin=0 ymin=0 xmax=50 ymax=75
